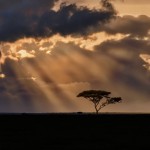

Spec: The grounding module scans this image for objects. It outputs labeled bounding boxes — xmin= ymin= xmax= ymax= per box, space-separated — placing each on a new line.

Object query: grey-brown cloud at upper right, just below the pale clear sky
xmin=101 ymin=15 xmax=150 ymax=37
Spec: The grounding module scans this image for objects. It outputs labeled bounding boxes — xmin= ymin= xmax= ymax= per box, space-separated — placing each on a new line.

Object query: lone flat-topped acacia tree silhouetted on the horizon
xmin=77 ymin=90 xmax=122 ymax=114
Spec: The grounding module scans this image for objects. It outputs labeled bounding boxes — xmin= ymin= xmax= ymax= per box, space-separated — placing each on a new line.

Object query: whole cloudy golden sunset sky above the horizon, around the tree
xmin=0 ymin=0 xmax=150 ymax=113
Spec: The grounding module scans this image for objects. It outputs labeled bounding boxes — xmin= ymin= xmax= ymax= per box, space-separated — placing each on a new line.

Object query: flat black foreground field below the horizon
xmin=0 ymin=113 xmax=150 ymax=150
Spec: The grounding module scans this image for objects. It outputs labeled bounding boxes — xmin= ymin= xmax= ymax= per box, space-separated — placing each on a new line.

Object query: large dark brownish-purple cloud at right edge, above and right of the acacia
xmin=95 ymin=37 xmax=150 ymax=99
